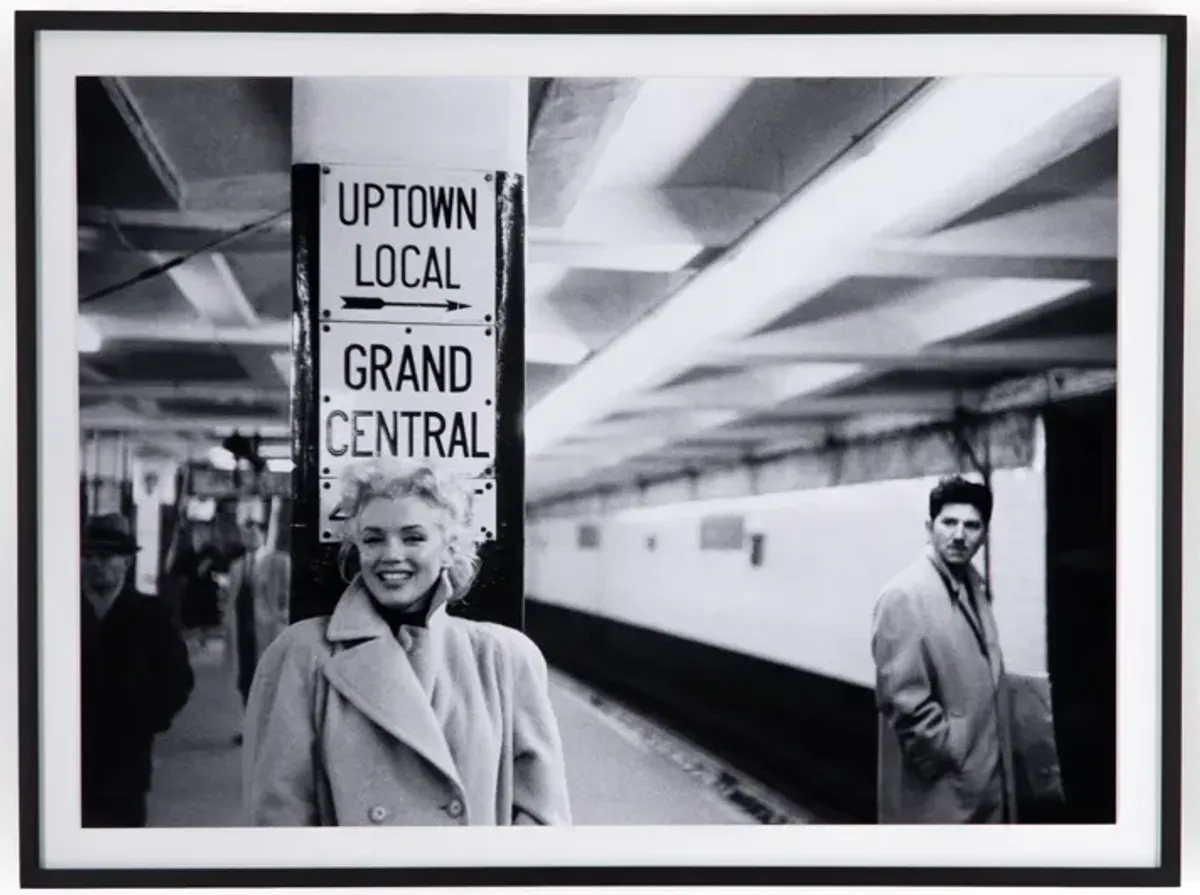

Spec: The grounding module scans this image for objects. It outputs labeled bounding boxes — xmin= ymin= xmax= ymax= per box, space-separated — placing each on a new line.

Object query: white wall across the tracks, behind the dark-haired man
xmin=526 ymin=468 xmax=1046 ymax=686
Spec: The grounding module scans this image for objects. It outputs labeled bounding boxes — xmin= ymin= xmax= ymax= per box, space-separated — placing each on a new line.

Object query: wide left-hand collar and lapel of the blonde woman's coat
xmin=325 ymin=579 xmax=458 ymax=783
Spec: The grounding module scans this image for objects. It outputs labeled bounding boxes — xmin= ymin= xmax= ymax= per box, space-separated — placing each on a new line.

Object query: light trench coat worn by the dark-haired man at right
xmin=871 ymin=548 xmax=1016 ymax=824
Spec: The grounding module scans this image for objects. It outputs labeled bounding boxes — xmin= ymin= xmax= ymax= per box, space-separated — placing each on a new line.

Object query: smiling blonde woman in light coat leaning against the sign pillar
xmin=244 ymin=459 xmax=570 ymax=827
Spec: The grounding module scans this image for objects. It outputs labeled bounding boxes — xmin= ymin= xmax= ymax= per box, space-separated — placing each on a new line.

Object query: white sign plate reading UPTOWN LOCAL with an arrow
xmin=319 ymin=164 xmax=497 ymax=325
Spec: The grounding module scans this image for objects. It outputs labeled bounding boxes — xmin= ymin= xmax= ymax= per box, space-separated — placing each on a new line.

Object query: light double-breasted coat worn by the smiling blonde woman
xmin=244 ymin=576 xmax=571 ymax=827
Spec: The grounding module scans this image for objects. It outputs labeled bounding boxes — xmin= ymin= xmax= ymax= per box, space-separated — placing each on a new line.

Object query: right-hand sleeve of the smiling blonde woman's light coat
xmin=512 ymin=639 xmax=571 ymax=827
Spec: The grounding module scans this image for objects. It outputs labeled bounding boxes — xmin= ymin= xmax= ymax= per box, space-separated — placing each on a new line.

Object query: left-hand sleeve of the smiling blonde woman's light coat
xmin=242 ymin=629 xmax=319 ymax=827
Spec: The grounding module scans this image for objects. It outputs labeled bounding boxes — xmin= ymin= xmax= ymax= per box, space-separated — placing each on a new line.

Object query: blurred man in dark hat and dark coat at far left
xmin=80 ymin=513 xmax=194 ymax=827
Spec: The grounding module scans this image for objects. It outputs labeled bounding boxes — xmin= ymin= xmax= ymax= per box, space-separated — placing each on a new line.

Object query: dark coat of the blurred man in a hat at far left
xmin=80 ymin=588 xmax=194 ymax=827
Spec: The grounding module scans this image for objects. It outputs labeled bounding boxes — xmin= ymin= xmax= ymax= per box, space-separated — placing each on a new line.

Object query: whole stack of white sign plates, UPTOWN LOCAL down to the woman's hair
xmin=317 ymin=166 xmax=498 ymax=542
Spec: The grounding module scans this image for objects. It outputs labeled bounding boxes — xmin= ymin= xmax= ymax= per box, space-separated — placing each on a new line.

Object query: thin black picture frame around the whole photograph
xmin=16 ymin=11 xmax=1187 ymax=888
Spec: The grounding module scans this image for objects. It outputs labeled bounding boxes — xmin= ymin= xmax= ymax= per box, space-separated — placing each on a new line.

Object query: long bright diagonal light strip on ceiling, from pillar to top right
xmin=526 ymin=77 xmax=1112 ymax=457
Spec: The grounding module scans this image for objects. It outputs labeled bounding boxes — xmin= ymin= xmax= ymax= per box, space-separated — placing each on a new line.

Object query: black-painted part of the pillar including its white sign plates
xmin=289 ymin=163 xmax=524 ymax=627
